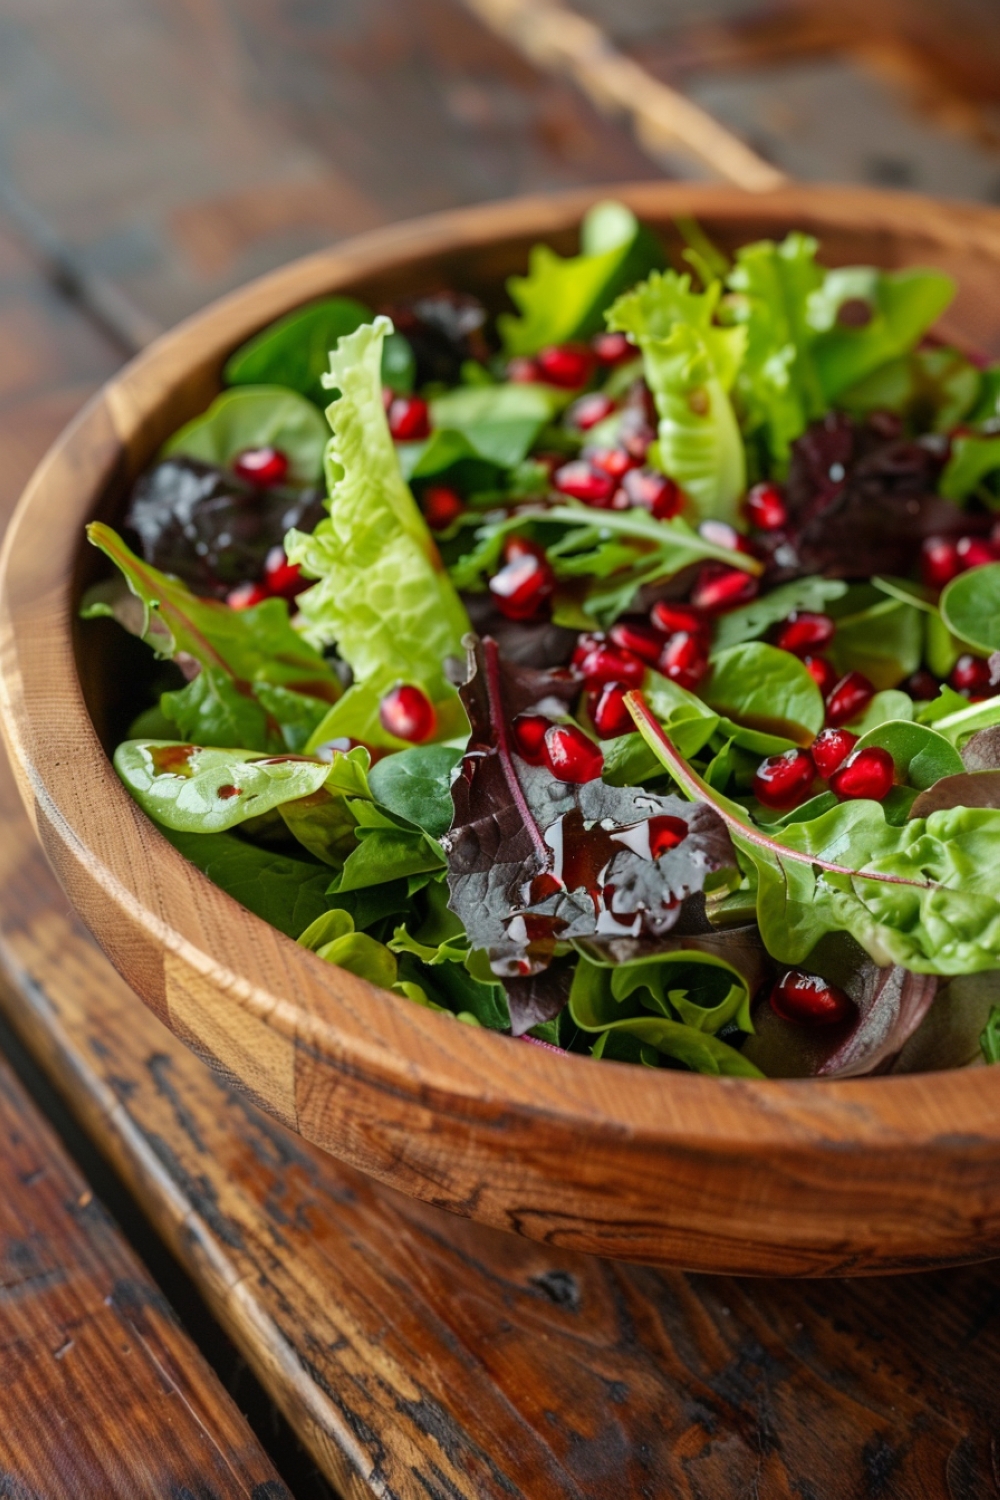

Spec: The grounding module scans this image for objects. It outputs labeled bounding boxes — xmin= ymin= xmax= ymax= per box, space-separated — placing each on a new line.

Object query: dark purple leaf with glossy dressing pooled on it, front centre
xmin=442 ymin=639 xmax=736 ymax=978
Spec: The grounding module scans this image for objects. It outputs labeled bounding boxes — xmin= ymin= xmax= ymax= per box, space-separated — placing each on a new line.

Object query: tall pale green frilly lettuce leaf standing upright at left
xmin=285 ymin=318 xmax=469 ymax=750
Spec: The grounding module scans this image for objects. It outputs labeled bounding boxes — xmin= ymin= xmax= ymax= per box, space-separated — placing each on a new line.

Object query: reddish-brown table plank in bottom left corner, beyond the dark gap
xmin=0 ymin=1059 xmax=291 ymax=1500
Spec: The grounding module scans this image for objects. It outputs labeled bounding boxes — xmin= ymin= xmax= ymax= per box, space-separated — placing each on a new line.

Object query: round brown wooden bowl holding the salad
xmin=0 ymin=183 xmax=1000 ymax=1275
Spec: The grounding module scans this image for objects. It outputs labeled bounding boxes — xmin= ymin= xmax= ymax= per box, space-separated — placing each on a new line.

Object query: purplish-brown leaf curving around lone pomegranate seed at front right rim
xmin=744 ymin=933 xmax=940 ymax=1079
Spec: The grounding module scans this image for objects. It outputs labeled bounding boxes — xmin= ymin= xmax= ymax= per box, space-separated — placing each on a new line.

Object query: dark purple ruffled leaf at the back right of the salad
xmin=759 ymin=411 xmax=971 ymax=584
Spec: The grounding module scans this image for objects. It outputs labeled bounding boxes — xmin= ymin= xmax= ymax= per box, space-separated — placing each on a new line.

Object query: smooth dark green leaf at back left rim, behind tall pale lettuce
xmin=223 ymin=297 xmax=372 ymax=408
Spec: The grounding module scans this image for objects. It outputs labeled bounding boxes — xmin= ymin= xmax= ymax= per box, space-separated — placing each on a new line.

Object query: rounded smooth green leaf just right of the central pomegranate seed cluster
xmin=703 ymin=641 xmax=825 ymax=744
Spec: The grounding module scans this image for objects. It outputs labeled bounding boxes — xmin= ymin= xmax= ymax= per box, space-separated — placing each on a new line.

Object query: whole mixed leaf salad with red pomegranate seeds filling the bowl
xmin=82 ymin=203 xmax=1000 ymax=1077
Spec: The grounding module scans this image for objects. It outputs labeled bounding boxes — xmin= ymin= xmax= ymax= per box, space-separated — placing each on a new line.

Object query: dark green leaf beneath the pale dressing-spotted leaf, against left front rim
xmin=160 ymin=828 xmax=330 ymax=938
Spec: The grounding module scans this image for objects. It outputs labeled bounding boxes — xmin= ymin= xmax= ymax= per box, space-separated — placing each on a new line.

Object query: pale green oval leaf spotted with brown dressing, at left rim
xmin=114 ymin=740 xmax=330 ymax=834
